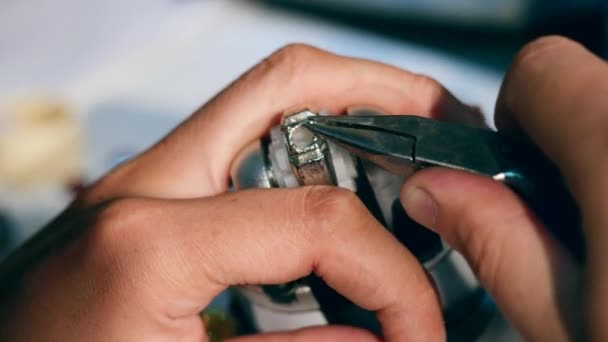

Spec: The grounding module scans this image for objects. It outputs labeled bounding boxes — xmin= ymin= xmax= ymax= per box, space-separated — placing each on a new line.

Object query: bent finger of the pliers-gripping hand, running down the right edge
xmin=496 ymin=37 xmax=608 ymax=340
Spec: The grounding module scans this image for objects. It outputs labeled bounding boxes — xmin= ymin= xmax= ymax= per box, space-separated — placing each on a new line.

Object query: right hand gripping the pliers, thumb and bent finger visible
xmin=401 ymin=37 xmax=608 ymax=341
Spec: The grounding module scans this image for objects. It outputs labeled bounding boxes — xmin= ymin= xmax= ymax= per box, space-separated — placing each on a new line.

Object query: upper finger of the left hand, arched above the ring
xmin=86 ymin=45 xmax=479 ymax=202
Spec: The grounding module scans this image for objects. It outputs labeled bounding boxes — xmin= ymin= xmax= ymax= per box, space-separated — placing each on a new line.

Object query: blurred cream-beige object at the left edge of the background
xmin=0 ymin=98 xmax=83 ymax=191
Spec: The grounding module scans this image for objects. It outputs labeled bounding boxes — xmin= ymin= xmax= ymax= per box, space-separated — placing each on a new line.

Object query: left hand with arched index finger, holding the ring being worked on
xmin=0 ymin=45 xmax=484 ymax=341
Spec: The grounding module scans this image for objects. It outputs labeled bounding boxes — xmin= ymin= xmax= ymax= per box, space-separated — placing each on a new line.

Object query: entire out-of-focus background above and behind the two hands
xmin=0 ymin=0 xmax=608 ymax=338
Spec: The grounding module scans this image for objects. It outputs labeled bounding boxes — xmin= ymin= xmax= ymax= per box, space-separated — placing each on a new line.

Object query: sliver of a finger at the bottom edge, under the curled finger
xmin=226 ymin=326 xmax=381 ymax=342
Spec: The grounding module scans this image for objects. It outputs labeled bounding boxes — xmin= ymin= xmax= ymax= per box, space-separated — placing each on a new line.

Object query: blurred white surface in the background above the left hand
xmin=0 ymin=0 xmax=500 ymax=120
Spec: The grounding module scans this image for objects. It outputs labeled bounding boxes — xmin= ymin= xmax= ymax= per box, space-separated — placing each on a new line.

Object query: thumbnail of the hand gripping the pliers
xmin=401 ymin=186 xmax=437 ymax=229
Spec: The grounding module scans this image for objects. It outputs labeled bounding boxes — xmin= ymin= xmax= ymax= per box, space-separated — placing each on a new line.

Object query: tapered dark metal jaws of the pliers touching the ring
xmin=305 ymin=115 xmax=514 ymax=177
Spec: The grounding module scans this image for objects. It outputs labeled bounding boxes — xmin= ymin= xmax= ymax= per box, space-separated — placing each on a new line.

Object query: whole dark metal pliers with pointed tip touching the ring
xmin=304 ymin=115 xmax=584 ymax=261
